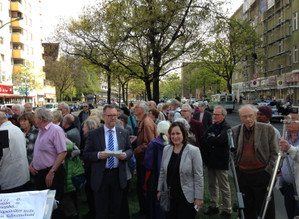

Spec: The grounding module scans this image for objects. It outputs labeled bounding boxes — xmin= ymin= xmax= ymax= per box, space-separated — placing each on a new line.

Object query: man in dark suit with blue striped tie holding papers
xmin=83 ymin=105 xmax=133 ymax=219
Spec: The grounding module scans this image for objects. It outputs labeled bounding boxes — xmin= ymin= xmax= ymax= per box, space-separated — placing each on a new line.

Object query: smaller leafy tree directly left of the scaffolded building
xmin=199 ymin=17 xmax=260 ymax=93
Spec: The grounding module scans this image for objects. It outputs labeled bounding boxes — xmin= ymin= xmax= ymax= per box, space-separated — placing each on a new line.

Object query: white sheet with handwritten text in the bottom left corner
xmin=0 ymin=190 xmax=49 ymax=219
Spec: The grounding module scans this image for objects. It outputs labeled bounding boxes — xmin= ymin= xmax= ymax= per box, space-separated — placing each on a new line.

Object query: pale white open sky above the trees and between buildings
xmin=42 ymin=0 xmax=243 ymax=39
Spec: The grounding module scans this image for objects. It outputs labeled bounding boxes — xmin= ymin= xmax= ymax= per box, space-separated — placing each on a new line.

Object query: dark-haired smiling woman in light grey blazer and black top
xmin=157 ymin=122 xmax=204 ymax=219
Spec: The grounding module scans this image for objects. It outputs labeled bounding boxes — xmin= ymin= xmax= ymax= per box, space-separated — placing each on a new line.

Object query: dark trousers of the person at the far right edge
xmin=282 ymin=183 xmax=299 ymax=219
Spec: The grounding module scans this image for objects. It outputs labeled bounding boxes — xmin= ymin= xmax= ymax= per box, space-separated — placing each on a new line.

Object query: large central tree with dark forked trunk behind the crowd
xmin=111 ymin=0 xmax=214 ymax=102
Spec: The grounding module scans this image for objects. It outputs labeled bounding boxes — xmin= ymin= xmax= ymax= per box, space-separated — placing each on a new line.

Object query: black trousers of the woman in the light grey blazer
xmin=169 ymin=195 xmax=198 ymax=219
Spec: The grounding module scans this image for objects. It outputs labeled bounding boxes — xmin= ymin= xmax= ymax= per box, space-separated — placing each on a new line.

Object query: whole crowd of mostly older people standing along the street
xmin=0 ymin=99 xmax=299 ymax=219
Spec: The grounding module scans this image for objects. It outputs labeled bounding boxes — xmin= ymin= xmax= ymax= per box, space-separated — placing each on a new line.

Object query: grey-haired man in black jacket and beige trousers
xmin=203 ymin=106 xmax=232 ymax=219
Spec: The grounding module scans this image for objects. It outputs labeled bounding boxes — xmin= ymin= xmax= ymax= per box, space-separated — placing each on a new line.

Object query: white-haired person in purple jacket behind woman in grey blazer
xmin=144 ymin=121 xmax=170 ymax=219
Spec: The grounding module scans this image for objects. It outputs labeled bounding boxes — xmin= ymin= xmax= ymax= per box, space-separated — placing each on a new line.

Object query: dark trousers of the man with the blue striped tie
xmin=94 ymin=168 xmax=123 ymax=219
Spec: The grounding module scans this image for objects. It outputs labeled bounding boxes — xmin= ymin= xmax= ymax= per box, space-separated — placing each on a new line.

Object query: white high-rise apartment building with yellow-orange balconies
xmin=0 ymin=0 xmax=56 ymax=106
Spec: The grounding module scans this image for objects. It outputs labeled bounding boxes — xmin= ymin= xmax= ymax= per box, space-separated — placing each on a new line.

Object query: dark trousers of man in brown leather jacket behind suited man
xmin=136 ymin=162 xmax=149 ymax=215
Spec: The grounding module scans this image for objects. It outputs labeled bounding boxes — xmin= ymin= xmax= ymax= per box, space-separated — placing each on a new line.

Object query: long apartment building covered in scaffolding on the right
xmin=232 ymin=0 xmax=299 ymax=105
